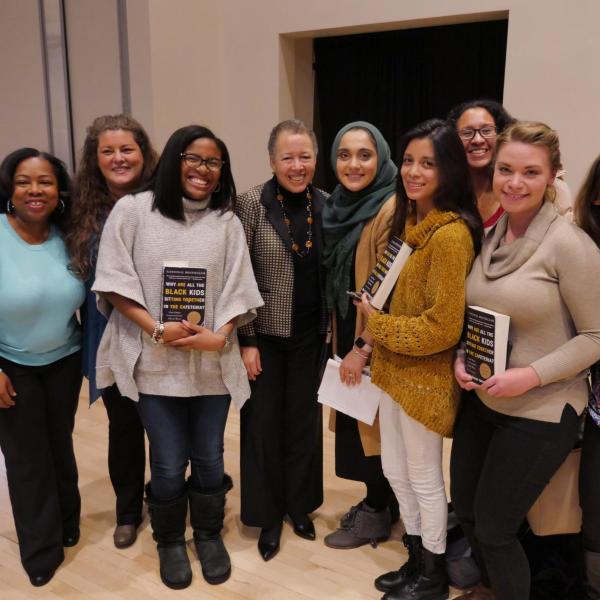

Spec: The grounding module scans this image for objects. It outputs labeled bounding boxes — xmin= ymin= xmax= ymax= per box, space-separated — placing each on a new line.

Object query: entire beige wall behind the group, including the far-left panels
xmin=0 ymin=0 xmax=600 ymax=190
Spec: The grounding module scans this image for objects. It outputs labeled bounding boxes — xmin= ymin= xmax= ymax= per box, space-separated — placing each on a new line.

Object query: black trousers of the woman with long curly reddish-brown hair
xmin=102 ymin=385 xmax=146 ymax=527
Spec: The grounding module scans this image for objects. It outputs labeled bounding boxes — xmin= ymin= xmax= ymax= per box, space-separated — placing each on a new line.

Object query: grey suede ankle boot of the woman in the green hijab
xmin=325 ymin=501 xmax=392 ymax=549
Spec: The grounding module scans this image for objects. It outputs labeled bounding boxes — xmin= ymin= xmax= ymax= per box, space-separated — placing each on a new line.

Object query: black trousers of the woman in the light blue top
xmin=0 ymin=352 xmax=82 ymax=575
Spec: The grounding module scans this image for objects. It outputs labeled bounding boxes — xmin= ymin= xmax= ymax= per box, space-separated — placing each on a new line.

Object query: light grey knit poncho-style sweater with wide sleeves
xmin=92 ymin=192 xmax=263 ymax=408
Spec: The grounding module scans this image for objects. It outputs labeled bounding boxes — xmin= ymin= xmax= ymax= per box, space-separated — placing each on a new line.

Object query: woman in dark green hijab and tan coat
xmin=323 ymin=121 xmax=398 ymax=548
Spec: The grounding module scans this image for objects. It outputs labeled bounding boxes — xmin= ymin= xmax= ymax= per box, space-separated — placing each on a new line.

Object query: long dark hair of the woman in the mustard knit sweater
xmin=390 ymin=119 xmax=483 ymax=254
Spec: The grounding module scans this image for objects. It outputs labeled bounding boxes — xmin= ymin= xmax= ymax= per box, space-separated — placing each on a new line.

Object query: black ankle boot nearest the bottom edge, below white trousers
xmin=383 ymin=548 xmax=450 ymax=600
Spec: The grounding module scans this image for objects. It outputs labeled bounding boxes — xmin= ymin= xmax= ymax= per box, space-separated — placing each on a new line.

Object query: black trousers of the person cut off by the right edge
xmin=579 ymin=415 xmax=600 ymax=552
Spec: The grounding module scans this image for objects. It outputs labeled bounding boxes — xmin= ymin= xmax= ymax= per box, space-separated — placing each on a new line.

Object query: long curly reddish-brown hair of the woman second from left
xmin=65 ymin=114 xmax=158 ymax=280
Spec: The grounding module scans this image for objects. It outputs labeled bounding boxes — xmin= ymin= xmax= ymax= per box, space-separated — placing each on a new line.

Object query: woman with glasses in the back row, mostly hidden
xmin=448 ymin=99 xmax=513 ymax=232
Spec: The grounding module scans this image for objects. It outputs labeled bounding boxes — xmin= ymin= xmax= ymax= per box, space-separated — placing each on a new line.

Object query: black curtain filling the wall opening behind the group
xmin=314 ymin=20 xmax=508 ymax=191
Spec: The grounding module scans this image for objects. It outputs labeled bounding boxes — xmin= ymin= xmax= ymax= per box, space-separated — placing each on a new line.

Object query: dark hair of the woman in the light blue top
xmin=0 ymin=148 xmax=71 ymax=235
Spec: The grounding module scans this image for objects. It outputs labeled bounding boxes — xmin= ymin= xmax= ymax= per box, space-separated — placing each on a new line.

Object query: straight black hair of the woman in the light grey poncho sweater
xmin=146 ymin=125 xmax=236 ymax=221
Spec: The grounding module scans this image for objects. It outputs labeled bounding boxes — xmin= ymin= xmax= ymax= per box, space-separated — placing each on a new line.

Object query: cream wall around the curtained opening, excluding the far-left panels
xmin=134 ymin=0 xmax=600 ymax=189
